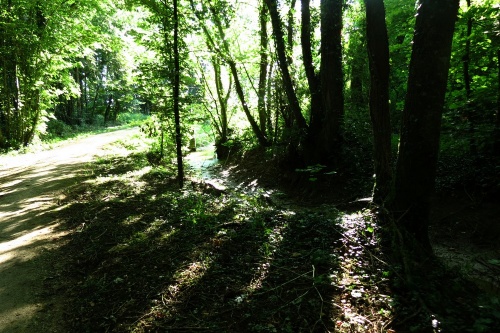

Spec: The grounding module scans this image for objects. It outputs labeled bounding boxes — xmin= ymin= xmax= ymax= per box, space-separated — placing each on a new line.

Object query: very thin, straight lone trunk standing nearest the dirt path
xmin=173 ymin=0 xmax=184 ymax=188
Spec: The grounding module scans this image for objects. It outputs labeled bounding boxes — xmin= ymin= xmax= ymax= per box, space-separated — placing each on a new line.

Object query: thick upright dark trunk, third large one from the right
xmin=319 ymin=0 xmax=344 ymax=161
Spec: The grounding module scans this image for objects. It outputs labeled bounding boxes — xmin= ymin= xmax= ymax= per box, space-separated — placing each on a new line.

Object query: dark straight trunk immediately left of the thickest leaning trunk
xmin=365 ymin=0 xmax=392 ymax=204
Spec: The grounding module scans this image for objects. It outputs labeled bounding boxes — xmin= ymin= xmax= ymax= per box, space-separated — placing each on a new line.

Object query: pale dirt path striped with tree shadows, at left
xmin=0 ymin=129 xmax=138 ymax=333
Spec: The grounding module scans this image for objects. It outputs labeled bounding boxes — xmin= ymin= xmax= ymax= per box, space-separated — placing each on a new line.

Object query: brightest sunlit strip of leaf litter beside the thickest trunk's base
xmin=330 ymin=211 xmax=393 ymax=332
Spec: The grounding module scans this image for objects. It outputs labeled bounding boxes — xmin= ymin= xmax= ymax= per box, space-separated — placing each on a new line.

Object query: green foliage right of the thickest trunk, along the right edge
xmin=442 ymin=0 xmax=500 ymax=155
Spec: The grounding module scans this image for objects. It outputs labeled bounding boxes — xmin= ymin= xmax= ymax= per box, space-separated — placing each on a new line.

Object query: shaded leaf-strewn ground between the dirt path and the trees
xmin=39 ymin=138 xmax=497 ymax=333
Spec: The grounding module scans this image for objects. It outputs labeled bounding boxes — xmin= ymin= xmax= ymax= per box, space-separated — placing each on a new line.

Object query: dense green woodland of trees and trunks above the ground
xmin=0 ymin=0 xmax=500 ymax=330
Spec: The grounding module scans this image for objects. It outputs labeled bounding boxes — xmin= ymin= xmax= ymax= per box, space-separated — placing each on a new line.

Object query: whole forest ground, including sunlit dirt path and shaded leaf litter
xmin=0 ymin=126 xmax=500 ymax=333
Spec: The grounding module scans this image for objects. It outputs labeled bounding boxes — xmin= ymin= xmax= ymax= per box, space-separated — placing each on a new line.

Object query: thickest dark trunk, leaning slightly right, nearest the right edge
xmin=391 ymin=0 xmax=459 ymax=253
